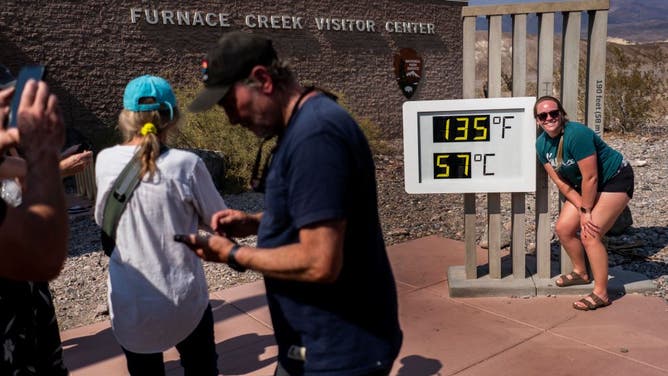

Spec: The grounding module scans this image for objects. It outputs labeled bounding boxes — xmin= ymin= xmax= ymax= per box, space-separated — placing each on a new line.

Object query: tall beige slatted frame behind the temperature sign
xmin=462 ymin=0 xmax=610 ymax=279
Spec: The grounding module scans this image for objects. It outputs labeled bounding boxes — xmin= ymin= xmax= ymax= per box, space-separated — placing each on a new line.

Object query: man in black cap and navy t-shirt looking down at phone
xmin=182 ymin=32 xmax=402 ymax=376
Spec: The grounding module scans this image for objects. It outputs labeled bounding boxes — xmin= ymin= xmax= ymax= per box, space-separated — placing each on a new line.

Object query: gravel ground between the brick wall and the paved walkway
xmin=51 ymin=131 xmax=668 ymax=330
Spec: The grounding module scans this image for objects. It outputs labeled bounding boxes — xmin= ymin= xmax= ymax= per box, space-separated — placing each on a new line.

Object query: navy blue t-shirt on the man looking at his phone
xmin=258 ymin=94 xmax=402 ymax=376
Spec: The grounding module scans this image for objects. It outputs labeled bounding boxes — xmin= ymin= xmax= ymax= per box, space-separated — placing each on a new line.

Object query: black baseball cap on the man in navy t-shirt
xmin=188 ymin=31 xmax=278 ymax=112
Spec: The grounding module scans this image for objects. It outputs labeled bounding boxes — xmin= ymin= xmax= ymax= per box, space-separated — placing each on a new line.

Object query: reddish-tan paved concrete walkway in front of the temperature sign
xmin=62 ymin=237 xmax=668 ymax=376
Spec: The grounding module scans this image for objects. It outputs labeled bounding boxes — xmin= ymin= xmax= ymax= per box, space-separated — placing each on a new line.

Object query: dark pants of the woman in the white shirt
xmin=121 ymin=305 xmax=218 ymax=376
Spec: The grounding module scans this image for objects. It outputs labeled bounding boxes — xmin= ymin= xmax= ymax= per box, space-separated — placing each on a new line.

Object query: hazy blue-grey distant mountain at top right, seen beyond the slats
xmin=476 ymin=0 xmax=668 ymax=43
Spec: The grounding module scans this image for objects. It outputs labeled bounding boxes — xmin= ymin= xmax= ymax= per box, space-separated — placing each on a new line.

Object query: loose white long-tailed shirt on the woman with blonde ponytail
xmin=95 ymin=145 xmax=226 ymax=353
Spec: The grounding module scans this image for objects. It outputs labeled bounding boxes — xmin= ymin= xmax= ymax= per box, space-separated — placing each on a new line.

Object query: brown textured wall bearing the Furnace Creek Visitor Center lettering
xmin=0 ymin=0 xmax=466 ymax=144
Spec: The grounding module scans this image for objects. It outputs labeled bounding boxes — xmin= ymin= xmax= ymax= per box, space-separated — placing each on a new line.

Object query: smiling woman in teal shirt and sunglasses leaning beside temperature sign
xmin=533 ymin=96 xmax=634 ymax=311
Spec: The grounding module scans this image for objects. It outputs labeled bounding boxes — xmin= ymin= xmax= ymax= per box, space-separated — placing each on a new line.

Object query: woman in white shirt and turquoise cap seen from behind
xmin=95 ymin=75 xmax=226 ymax=375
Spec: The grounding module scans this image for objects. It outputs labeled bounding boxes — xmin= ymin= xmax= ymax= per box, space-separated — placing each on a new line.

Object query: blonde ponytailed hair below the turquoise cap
xmin=118 ymin=98 xmax=179 ymax=178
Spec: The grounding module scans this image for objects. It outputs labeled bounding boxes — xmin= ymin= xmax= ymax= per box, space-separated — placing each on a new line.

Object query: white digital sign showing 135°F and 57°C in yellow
xmin=404 ymin=97 xmax=536 ymax=193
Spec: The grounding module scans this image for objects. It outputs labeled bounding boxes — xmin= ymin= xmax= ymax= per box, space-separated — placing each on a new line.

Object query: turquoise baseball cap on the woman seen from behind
xmin=123 ymin=74 xmax=176 ymax=120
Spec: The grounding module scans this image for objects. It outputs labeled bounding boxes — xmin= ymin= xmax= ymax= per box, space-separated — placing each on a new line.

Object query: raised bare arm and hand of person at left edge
xmin=0 ymin=67 xmax=68 ymax=281
